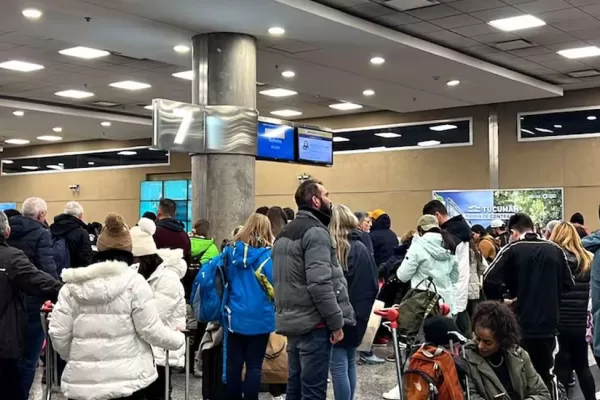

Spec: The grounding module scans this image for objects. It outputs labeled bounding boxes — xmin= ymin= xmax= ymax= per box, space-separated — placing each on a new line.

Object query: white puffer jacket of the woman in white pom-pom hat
xmin=148 ymin=249 xmax=187 ymax=367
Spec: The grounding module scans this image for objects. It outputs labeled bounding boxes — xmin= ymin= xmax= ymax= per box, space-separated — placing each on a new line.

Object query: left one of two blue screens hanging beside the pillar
xmin=256 ymin=121 xmax=294 ymax=161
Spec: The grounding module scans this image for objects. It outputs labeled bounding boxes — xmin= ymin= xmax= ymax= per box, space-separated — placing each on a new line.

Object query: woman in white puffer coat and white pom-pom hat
xmin=131 ymin=218 xmax=187 ymax=400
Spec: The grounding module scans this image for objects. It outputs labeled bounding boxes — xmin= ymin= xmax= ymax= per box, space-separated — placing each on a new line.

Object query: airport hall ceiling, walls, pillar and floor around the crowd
xmin=0 ymin=0 xmax=600 ymax=400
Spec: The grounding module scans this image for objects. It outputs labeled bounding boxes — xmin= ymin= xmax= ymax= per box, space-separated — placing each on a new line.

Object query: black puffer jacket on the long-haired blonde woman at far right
xmin=558 ymin=250 xmax=590 ymax=337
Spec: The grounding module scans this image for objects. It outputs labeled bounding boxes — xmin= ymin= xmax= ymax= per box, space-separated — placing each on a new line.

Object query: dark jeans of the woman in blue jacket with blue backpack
xmin=227 ymin=332 xmax=269 ymax=400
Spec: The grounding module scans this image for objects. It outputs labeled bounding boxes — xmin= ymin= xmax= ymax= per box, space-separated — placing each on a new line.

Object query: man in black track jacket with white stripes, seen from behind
xmin=483 ymin=214 xmax=575 ymax=393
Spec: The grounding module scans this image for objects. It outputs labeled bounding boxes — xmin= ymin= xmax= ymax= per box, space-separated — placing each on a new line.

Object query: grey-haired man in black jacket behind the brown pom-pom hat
xmin=50 ymin=201 xmax=94 ymax=272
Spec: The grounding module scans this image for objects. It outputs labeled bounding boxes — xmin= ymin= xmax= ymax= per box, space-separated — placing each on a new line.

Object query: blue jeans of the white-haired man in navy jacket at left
xmin=18 ymin=298 xmax=46 ymax=396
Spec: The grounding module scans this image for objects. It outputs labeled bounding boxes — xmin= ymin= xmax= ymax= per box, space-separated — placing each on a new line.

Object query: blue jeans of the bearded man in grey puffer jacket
xmin=286 ymin=328 xmax=331 ymax=400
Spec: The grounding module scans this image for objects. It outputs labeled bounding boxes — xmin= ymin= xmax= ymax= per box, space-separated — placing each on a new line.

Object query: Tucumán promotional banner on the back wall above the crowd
xmin=433 ymin=188 xmax=564 ymax=227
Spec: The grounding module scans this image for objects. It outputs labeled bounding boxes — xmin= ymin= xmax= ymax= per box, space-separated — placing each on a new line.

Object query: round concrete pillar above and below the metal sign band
xmin=191 ymin=33 xmax=256 ymax=244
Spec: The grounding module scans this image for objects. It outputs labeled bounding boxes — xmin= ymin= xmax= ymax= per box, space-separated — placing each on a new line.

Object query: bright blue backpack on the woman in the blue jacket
xmin=190 ymin=249 xmax=228 ymax=323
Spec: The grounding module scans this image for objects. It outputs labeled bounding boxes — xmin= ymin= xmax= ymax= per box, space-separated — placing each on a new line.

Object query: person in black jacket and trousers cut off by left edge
xmin=0 ymin=211 xmax=62 ymax=400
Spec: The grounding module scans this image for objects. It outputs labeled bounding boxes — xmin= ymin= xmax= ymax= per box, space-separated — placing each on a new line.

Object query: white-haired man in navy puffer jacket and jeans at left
xmin=8 ymin=197 xmax=58 ymax=393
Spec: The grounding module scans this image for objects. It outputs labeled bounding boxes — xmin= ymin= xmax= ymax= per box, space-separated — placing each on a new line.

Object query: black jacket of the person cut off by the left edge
xmin=0 ymin=238 xmax=62 ymax=359
